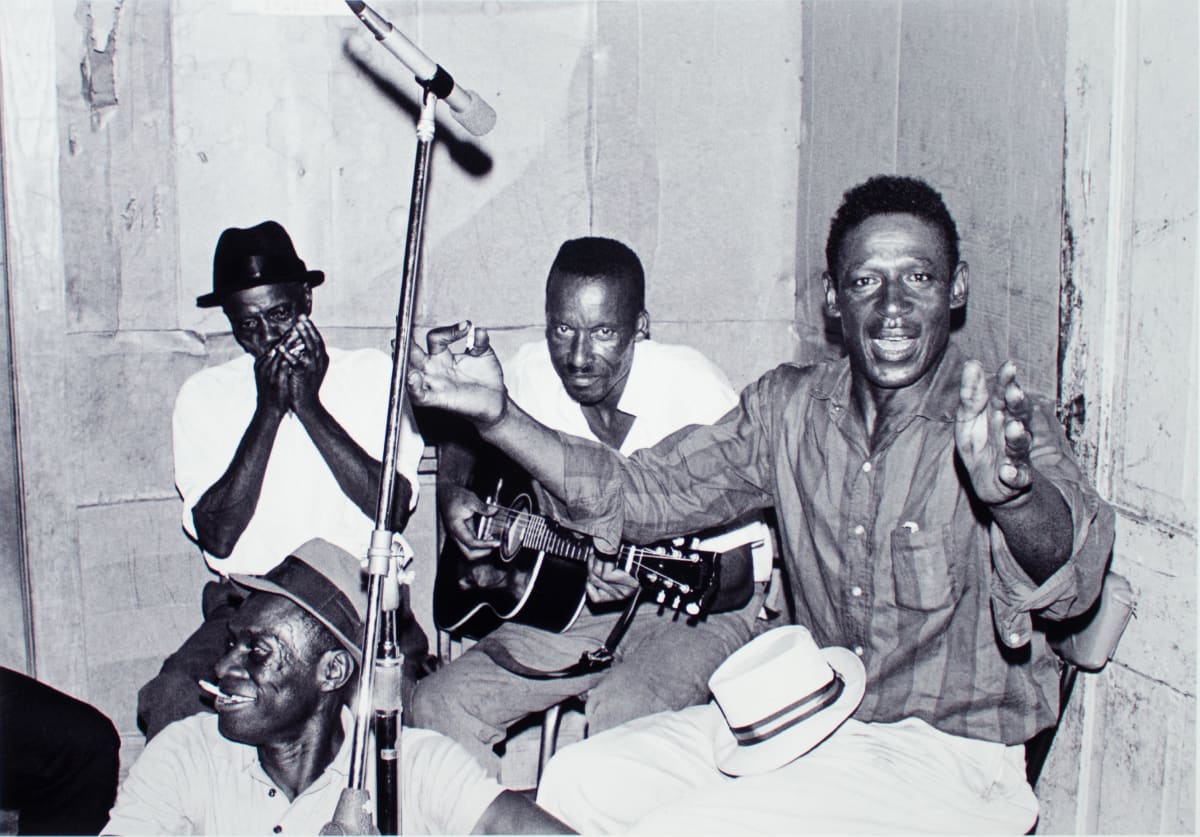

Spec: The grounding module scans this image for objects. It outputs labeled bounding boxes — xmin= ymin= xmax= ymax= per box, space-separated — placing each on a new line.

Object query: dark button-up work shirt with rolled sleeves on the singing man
xmin=544 ymin=348 xmax=1114 ymax=743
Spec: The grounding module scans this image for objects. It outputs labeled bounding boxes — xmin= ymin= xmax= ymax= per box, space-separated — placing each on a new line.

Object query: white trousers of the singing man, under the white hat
xmin=538 ymin=703 xmax=1038 ymax=835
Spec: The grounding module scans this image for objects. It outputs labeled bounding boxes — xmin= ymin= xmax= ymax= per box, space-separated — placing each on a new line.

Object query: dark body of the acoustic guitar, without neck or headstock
xmin=433 ymin=466 xmax=588 ymax=639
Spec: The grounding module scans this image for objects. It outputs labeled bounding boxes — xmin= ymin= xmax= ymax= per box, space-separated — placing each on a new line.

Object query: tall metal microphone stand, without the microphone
xmin=320 ymin=86 xmax=438 ymax=835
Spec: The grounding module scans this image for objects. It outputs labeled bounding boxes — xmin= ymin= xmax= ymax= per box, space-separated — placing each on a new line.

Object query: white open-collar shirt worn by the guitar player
xmin=504 ymin=339 xmax=774 ymax=580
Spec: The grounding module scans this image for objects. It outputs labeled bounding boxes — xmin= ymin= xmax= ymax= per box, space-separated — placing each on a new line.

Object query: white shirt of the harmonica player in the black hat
xmin=172 ymin=349 xmax=425 ymax=576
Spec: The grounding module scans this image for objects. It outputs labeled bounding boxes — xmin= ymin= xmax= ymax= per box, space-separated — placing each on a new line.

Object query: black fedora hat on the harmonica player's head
xmin=196 ymin=221 xmax=325 ymax=308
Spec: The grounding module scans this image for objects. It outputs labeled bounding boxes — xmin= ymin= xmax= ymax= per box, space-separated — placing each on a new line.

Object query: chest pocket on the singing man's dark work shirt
xmin=892 ymin=524 xmax=962 ymax=612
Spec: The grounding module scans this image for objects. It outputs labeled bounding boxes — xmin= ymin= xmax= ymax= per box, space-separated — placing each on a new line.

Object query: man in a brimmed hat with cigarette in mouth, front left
xmin=102 ymin=540 xmax=570 ymax=835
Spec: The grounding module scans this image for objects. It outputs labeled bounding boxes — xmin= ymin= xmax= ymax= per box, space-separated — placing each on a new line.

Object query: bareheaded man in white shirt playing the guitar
xmin=412 ymin=237 xmax=772 ymax=771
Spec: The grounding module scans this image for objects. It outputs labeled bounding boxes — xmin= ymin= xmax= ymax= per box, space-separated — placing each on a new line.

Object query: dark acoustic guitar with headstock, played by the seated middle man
xmin=433 ymin=465 xmax=720 ymax=638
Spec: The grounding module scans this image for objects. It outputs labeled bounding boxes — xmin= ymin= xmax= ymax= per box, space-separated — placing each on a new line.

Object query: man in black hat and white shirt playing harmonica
xmin=138 ymin=221 xmax=428 ymax=739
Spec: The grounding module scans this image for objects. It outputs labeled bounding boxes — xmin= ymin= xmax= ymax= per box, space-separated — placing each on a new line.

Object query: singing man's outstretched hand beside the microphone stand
xmin=407 ymin=320 xmax=506 ymax=426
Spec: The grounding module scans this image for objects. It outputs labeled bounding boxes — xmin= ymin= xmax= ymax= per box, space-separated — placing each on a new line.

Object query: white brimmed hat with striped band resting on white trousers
xmin=708 ymin=625 xmax=866 ymax=776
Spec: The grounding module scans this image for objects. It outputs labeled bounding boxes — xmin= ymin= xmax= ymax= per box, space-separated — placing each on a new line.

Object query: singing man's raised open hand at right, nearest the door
xmin=954 ymin=361 xmax=1033 ymax=505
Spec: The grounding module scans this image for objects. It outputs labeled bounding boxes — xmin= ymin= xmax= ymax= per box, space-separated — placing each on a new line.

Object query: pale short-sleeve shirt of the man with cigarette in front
xmin=101 ymin=709 xmax=503 ymax=835
